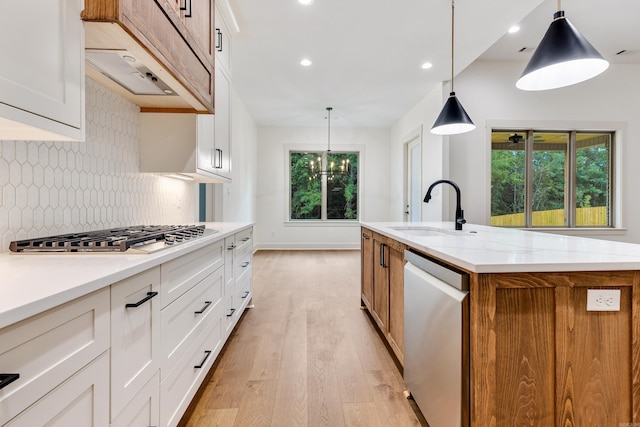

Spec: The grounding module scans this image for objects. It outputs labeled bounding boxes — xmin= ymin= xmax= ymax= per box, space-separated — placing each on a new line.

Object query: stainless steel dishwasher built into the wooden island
xmin=404 ymin=251 xmax=470 ymax=427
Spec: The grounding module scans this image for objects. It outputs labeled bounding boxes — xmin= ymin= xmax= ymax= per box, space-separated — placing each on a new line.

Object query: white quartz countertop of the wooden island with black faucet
xmin=362 ymin=222 xmax=640 ymax=273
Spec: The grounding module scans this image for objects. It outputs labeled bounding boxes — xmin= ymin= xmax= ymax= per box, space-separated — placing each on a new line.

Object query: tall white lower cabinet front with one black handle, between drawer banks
xmin=111 ymin=267 xmax=160 ymax=420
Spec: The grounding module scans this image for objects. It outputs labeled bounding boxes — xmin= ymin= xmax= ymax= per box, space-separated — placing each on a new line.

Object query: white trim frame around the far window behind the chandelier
xmin=283 ymin=144 xmax=365 ymax=226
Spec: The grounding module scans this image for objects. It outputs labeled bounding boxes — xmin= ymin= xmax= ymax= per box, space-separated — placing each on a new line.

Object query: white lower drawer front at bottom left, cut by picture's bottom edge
xmin=2 ymin=351 xmax=109 ymax=427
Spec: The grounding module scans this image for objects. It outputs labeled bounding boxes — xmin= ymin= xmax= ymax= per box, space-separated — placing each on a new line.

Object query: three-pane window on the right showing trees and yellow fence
xmin=491 ymin=129 xmax=614 ymax=228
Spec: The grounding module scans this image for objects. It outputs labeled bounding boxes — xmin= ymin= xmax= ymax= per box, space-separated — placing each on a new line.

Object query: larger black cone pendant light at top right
xmin=516 ymin=0 xmax=609 ymax=90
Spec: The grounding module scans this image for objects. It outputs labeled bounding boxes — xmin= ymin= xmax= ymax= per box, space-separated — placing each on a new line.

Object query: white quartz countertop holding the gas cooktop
xmin=0 ymin=222 xmax=253 ymax=328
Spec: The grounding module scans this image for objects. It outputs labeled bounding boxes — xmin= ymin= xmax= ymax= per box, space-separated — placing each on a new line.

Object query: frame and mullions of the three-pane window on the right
xmin=488 ymin=126 xmax=620 ymax=231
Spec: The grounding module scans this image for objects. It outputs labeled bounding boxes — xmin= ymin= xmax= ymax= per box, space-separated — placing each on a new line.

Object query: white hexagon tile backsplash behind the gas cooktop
xmin=0 ymin=78 xmax=198 ymax=252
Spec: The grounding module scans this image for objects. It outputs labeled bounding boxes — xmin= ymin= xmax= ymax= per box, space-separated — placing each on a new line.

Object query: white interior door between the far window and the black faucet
xmin=404 ymin=134 xmax=422 ymax=222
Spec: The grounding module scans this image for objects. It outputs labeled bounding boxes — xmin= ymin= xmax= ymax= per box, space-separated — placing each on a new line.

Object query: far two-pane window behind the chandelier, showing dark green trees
xmin=289 ymin=151 xmax=359 ymax=221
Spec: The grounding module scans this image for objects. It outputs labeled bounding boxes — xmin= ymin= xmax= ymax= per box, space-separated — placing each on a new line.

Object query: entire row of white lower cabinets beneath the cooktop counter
xmin=0 ymin=227 xmax=253 ymax=427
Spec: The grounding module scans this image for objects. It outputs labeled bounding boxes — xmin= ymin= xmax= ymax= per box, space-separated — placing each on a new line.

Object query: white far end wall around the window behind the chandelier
xmin=254 ymin=127 xmax=390 ymax=249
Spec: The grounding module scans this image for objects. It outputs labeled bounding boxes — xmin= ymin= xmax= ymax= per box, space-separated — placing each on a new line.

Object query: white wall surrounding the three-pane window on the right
xmin=450 ymin=62 xmax=640 ymax=243
